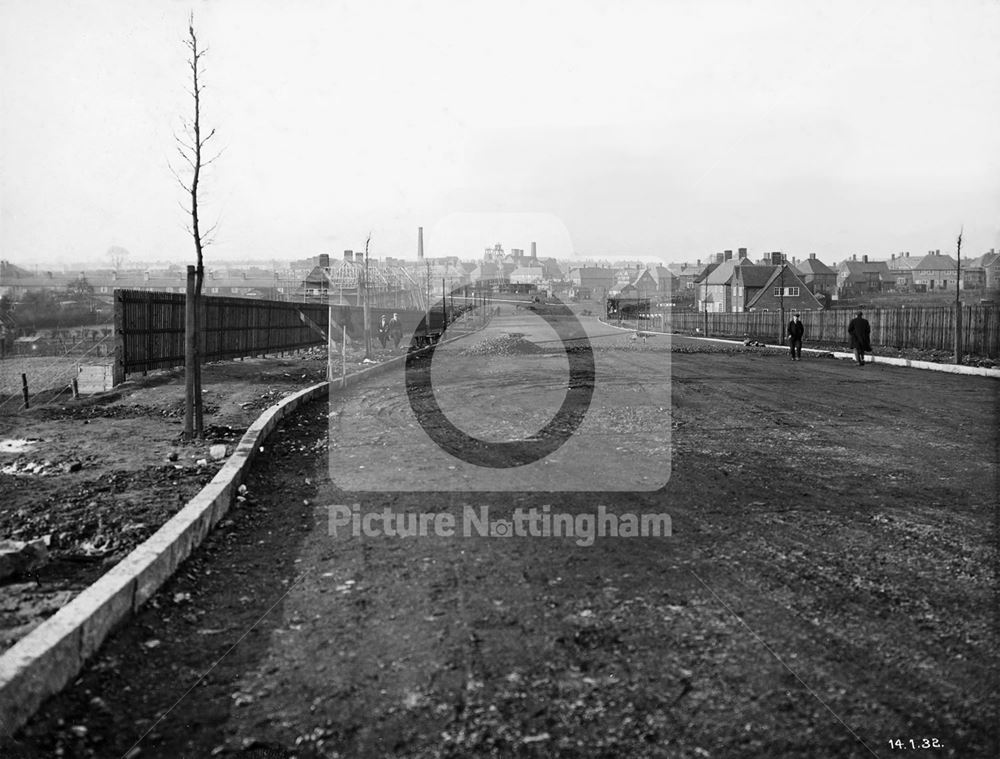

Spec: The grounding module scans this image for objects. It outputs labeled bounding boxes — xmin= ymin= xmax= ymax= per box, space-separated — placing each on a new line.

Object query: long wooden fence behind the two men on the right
xmin=642 ymin=305 xmax=1000 ymax=358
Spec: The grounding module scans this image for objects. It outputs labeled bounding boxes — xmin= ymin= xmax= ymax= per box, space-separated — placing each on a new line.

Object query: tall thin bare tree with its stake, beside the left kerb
xmin=174 ymin=13 xmax=219 ymax=439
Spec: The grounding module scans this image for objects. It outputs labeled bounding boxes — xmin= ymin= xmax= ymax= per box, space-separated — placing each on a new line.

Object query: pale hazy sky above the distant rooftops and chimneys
xmin=0 ymin=0 xmax=1000 ymax=266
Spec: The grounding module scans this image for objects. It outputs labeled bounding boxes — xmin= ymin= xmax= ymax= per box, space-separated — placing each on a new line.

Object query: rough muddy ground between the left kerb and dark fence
xmin=0 ymin=351 xmax=374 ymax=652
